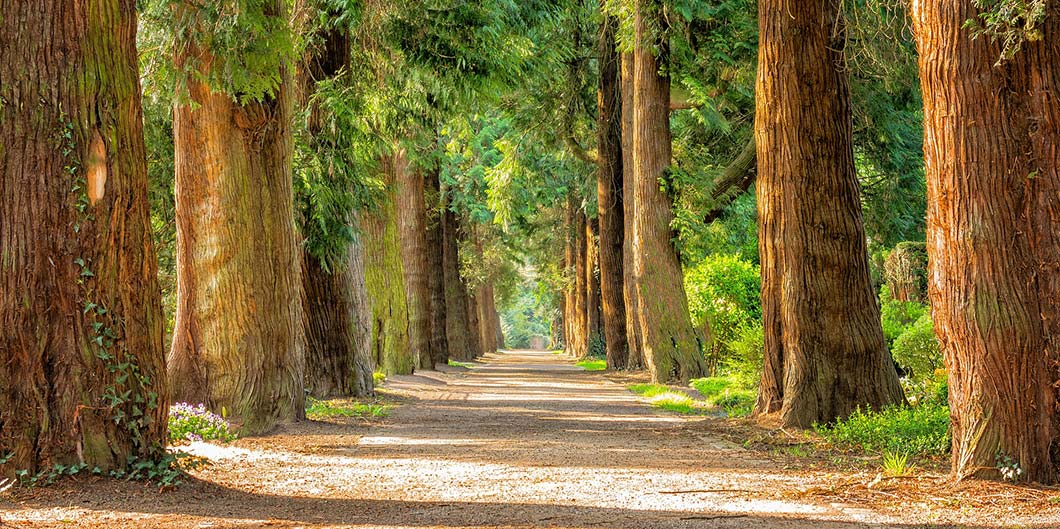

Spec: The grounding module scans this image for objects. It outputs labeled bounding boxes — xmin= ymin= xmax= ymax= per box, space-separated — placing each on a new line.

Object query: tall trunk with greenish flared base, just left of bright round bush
xmin=633 ymin=0 xmax=706 ymax=382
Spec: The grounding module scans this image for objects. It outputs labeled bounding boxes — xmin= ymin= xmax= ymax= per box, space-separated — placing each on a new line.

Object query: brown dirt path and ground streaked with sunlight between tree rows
xmin=0 ymin=351 xmax=1060 ymax=529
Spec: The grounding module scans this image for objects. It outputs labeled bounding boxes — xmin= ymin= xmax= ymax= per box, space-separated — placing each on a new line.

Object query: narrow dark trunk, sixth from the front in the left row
xmin=426 ymin=167 xmax=449 ymax=366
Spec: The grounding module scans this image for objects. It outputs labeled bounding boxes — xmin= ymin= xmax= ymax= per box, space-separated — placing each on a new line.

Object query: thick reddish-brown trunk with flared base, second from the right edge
xmin=755 ymin=0 xmax=903 ymax=427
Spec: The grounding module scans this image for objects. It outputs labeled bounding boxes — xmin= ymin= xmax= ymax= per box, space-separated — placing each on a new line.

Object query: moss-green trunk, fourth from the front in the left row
xmin=361 ymin=158 xmax=416 ymax=375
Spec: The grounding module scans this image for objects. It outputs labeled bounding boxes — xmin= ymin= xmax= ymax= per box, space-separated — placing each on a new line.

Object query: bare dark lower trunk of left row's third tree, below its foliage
xmin=302 ymin=240 xmax=375 ymax=399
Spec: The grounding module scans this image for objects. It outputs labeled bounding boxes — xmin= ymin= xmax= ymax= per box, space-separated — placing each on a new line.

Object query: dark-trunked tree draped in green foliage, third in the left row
xmin=295 ymin=2 xmax=374 ymax=399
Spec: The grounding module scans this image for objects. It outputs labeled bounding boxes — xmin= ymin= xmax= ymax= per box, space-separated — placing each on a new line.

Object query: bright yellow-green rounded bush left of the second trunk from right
xmin=685 ymin=255 xmax=762 ymax=370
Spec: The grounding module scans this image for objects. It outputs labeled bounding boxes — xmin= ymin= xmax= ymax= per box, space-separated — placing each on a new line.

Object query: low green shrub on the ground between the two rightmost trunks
xmin=816 ymin=403 xmax=950 ymax=455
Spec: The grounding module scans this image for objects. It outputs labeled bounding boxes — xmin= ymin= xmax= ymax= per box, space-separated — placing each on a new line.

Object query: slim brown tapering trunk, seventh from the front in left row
xmin=442 ymin=207 xmax=475 ymax=360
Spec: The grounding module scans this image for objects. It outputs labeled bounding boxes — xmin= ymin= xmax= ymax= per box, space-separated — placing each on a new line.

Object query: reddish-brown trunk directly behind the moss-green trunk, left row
xmin=393 ymin=149 xmax=435 ymax=369
